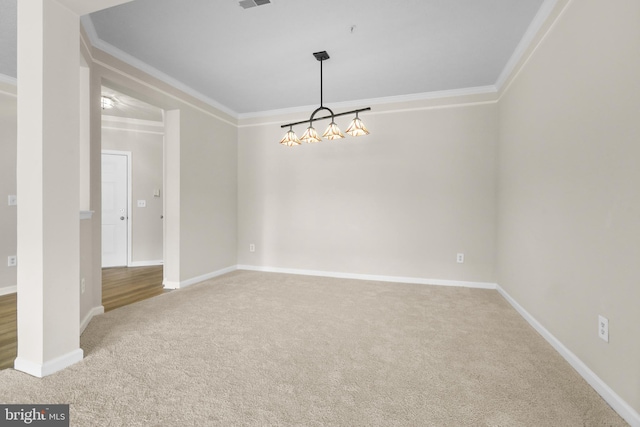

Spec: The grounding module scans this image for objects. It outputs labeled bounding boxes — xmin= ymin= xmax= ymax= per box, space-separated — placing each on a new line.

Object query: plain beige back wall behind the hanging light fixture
xmin=238 ymin=98 xmax=497 ymax=282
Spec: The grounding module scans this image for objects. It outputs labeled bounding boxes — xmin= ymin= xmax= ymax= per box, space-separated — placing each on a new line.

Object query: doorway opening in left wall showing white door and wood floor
xmin=101 ymin=82 xmax=165 ymax=311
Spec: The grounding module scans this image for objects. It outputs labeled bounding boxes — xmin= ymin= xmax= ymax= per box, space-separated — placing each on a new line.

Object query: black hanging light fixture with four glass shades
xmin=280 ymin=51 xmax=371 ymax=147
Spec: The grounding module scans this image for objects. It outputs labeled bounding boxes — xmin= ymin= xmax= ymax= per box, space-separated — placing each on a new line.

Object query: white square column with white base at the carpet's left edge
xmin=15 ymin=0 xmax=83 ymax=377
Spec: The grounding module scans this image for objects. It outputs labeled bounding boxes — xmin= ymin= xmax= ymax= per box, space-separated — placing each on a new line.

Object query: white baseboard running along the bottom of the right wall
xmin=496 ymin=285 xmax=640 ymax=427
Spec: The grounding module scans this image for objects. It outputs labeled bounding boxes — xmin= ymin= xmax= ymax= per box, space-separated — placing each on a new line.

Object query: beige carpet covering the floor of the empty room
xmin=0 ymin=271 xmax=626 ymax=426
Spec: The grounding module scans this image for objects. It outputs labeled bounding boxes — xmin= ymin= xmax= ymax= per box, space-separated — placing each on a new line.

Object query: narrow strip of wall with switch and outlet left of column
xmin=0 ymin=84 xmax=18 ymax=295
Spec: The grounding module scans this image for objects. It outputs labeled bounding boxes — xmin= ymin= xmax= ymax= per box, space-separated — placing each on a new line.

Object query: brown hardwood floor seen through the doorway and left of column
xmin=0 ymin=266 xmax=165 ymax=369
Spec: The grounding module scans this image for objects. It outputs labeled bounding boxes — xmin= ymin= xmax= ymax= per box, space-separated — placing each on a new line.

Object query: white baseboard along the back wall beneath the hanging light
xmin=237 ymin=265 xmax=497 ymax=289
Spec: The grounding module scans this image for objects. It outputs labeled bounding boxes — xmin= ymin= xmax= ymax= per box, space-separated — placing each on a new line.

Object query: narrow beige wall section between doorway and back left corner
xmin=180 ymin=108 xmax=238 ymax=282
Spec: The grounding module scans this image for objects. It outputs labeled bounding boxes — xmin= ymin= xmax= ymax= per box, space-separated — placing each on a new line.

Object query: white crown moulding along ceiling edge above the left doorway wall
xmin=81 ymin=15 xmax=238 ymax=119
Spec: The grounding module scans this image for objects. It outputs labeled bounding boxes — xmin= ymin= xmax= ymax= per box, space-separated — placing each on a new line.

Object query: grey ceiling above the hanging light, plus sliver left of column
xmin=0 ymin=0 xmax=551 ymax=116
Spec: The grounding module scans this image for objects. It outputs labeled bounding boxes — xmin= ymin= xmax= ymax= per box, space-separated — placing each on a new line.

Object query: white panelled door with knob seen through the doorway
xmin=102 ymin=153 xmax=129 ymax=267
